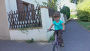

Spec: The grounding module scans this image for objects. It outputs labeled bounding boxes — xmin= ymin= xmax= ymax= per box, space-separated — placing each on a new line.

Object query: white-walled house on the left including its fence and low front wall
xmin=0 ymin=0 xmax=63 ymax=41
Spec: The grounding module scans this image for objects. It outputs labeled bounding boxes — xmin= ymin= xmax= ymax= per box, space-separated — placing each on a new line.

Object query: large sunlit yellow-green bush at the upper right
xmin=77 ymin=0 xmax=90 ymax=21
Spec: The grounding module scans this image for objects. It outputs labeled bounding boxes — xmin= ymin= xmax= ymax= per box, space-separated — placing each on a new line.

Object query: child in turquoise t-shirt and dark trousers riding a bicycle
xmin=48 ymin=13 xmax=65 ymax=47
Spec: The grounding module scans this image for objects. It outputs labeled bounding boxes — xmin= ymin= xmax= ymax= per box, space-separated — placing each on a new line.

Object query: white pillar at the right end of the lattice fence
xmin=41 ymin=7 xmax=51 ymax=29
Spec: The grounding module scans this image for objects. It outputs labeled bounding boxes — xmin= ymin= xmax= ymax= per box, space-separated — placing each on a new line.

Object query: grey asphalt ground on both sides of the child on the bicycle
xmin=0 ymin=21 xmax=90 ymax=51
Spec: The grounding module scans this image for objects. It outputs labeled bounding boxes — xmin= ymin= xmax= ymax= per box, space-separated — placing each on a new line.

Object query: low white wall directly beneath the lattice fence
xmin=10 ymin=29 xmax=47 ymax=41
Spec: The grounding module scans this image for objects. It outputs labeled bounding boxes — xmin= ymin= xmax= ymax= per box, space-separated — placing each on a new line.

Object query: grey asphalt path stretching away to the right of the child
xmin=62 ymin=21 xmax=90 ymax=51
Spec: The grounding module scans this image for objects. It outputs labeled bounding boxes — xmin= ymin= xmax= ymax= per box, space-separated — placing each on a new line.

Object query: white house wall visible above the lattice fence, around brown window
xmin=5 ymin=0 xmax=47 ymax=13
